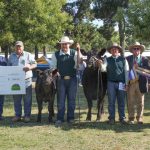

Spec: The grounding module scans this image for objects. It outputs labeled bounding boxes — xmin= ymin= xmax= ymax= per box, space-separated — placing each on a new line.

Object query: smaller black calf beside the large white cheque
xmin=35 ymin=69 xmax=57 ymax=122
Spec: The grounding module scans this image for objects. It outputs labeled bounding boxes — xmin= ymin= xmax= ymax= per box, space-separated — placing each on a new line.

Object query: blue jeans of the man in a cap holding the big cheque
xmin=13 ymin=85 xmax=32 ymax=117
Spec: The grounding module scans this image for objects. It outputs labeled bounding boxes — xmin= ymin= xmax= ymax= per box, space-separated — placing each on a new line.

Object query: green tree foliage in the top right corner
xmin=128 ymin=0 xmax=150 ymax=44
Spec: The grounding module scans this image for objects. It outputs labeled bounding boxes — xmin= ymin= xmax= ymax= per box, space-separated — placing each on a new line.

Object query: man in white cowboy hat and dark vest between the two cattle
xmin=52 ymin=36 xmax=81 ymax=126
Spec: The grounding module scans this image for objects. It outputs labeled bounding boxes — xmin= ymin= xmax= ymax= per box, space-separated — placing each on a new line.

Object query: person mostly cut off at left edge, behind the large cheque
xmin=0 ymin=56 xmax=7 ymax=121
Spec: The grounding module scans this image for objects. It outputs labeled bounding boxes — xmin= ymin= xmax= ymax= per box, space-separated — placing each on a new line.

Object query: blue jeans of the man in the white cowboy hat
xmin=57 ymin=77 xmax=77 ymax=122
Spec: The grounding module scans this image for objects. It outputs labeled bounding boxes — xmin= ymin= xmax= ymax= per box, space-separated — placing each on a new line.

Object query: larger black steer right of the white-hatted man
xmin=82 ymin=49 xmax=107 ymax=121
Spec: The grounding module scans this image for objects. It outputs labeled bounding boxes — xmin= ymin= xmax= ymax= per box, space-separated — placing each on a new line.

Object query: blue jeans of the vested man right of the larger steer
xmin=107 ymin=81 xmax=126 ymax=121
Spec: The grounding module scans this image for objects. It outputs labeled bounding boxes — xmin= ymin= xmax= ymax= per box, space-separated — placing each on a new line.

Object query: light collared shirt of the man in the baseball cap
xmin=8 ymin=51 xmax=36 ymax=87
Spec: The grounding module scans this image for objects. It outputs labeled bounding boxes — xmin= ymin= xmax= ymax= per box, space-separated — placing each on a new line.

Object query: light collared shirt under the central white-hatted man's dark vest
xmin=51 ymin=49 xmax=81 ymax=69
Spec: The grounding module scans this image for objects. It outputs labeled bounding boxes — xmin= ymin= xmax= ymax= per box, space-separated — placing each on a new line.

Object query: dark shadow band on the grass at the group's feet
xmin=0 ymin=112 xmax=150 ymax=133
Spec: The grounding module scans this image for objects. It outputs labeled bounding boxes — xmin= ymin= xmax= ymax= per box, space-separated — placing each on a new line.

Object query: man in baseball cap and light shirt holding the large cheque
xmin=8 ymin=41 xmax=37 ymax=122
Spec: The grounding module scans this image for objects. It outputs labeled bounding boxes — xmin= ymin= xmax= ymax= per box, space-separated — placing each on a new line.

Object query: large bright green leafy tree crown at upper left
xmin=0 ymin=0 xmax=71 ymax=57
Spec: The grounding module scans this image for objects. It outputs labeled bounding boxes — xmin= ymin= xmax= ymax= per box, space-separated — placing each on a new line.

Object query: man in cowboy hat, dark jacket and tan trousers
xmin=127 ymin=42 xmax=149 ymax=124
